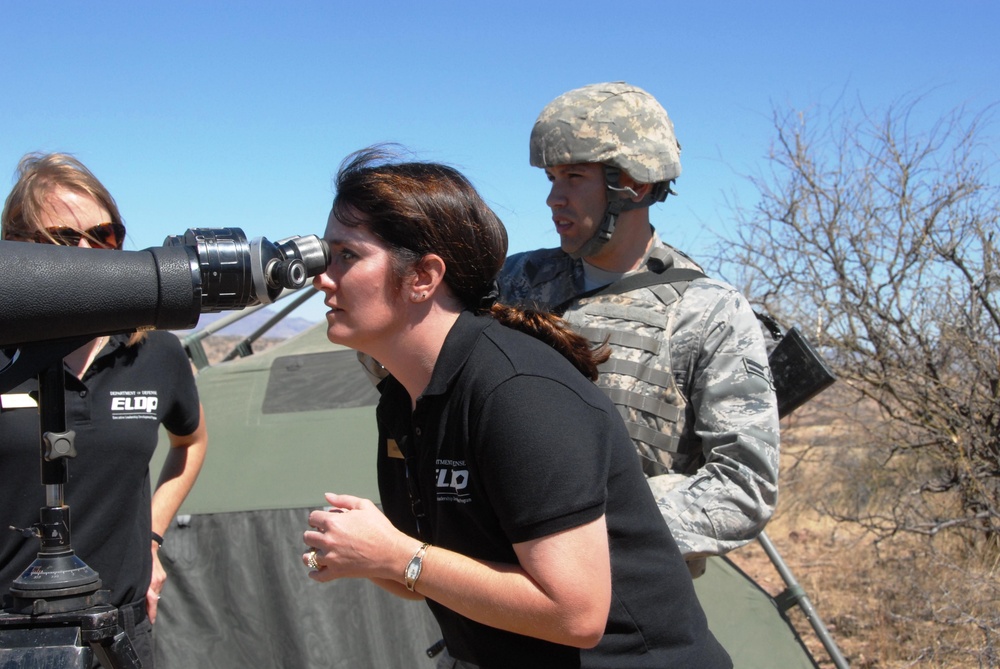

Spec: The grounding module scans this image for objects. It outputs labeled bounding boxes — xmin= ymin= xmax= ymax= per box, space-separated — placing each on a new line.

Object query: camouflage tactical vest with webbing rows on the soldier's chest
xmin=563 ymin=256 xmax=705 ymax=476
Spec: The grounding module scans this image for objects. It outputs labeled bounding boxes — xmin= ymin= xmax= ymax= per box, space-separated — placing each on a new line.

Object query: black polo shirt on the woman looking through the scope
xmin=377 ymin=312 xmax=732 ymax=669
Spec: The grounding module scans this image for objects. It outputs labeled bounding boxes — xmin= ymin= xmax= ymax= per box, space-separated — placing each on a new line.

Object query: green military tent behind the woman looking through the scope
xmin=153 ymin=300 xmax=817 ymax=669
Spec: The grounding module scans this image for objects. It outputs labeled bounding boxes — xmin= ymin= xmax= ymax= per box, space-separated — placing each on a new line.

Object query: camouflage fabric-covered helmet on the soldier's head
xmin=531 ymin=81 xmax=681 ymax=183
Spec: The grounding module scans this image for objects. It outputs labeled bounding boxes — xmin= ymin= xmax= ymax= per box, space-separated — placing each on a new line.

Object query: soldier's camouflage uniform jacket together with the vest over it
xmin=499 ymin=232 xmax=779 ymax=559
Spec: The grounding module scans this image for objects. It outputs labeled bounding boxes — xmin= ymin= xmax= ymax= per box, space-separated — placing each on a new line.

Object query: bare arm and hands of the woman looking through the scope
xmin=302 ymin=493 xmax=611 ymax=648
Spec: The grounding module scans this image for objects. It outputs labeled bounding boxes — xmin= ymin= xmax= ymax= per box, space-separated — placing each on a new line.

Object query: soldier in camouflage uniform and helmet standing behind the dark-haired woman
xmin=499 ymin=82 xmax=779 ymax=575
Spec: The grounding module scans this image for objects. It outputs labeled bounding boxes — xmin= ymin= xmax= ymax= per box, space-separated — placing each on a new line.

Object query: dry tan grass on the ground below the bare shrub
xmin=731 ymin=389 xmax=1000 ymax=669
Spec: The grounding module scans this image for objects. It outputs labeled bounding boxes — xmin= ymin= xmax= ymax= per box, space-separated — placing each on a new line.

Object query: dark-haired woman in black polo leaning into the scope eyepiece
xmin=302 ymin=148 xmax=732 ymax=669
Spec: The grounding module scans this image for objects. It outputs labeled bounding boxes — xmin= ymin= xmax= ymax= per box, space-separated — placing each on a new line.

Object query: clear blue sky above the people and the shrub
xmin=0 ymin=0 xmax=1000 ymax=314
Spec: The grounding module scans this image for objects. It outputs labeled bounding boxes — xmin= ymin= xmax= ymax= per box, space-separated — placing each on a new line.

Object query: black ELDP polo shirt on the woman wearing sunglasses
xmin=0 ymin=332 xmax=200 ymax=606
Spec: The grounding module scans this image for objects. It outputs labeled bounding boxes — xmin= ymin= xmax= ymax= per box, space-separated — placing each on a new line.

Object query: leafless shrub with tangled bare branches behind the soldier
xmin=725 ymin=92 xmax=1000 ymax=546
